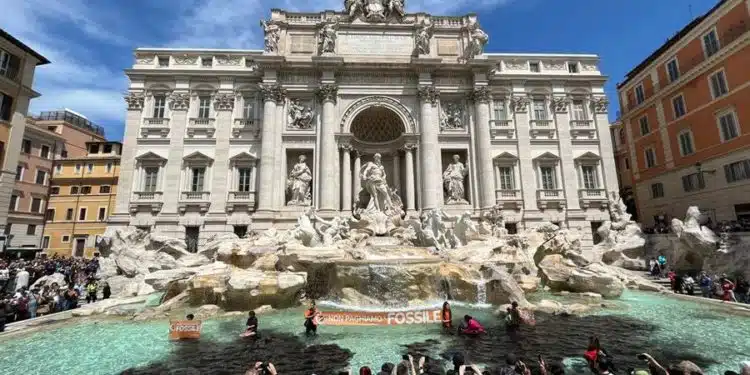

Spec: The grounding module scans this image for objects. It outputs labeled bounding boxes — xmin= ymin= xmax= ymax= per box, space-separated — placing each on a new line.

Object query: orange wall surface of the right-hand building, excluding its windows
xmin=618 ymin=0 xmax=750 ymax=226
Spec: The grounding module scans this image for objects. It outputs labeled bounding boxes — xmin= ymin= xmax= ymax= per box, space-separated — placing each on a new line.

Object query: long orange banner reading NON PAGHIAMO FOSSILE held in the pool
xmin=318 ymin=310 xmax=442 ymax=326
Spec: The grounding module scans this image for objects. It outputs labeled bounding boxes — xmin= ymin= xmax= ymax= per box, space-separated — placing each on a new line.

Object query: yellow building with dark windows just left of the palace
xmin=42 ymin=142 xmax=122 ymax=257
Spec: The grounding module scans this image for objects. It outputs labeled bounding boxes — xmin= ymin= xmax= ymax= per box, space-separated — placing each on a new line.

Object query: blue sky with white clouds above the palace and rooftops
xmin=0 ymin=0 xmax=717 ymax=140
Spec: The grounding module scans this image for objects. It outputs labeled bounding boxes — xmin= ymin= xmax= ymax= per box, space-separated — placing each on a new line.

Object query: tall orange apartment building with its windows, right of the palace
xmin=614 ymin=0 xmax=750 ymax=226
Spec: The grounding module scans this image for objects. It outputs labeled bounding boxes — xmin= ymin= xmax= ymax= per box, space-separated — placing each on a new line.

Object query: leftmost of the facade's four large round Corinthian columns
xmin=258 ymin=84 xmax=281 ymax=211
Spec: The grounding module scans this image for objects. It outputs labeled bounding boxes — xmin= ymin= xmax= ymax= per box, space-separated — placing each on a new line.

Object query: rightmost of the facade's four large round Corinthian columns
xmin=471 ymin=86 xmax=495 ymax=209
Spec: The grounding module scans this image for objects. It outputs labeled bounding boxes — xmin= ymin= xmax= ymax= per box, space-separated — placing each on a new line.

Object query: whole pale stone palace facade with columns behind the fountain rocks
xmin=110 ymin=0 xmax=617 ymax=250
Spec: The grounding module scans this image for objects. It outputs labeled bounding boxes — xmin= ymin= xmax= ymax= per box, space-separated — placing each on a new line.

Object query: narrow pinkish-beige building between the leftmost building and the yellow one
xmin=5 ymin=118 xmax=65 ymax=257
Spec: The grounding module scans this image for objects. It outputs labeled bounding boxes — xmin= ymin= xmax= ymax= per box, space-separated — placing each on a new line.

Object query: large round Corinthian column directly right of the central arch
xmin=417 ymin=85 xmax=443 ymax=210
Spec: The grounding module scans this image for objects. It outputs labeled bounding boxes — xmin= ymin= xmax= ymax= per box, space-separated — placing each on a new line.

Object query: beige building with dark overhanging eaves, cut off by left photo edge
xmin=0 ymin=29 xmax=49 ymax=247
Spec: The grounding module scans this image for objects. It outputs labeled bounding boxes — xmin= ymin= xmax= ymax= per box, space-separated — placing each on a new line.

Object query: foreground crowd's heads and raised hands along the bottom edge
xmin=245 ymin=337 xmax=750 ymax=375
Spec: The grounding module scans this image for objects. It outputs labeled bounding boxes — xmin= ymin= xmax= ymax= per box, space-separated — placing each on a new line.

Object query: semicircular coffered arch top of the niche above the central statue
xmin=341 ymin=95 xmax=417 ymax=137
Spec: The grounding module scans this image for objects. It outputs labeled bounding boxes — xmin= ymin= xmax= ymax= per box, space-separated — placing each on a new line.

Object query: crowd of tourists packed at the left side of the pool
xmin=0 ymin=256 xmax=111 ymax=332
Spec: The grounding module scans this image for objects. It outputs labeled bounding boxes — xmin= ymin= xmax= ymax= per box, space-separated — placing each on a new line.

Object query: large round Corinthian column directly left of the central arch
xmin=318 ymin=84 xmax=340 ymax=212
